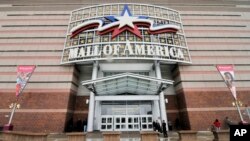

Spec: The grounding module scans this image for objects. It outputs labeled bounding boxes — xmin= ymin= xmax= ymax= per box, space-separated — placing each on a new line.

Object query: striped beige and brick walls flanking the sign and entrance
xmin=0 ymin=0 xmax=250 ymax=132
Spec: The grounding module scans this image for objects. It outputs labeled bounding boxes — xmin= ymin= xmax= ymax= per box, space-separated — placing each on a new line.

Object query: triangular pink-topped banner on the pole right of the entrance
xmin=216 ymin=65 xmax=237 ymax=100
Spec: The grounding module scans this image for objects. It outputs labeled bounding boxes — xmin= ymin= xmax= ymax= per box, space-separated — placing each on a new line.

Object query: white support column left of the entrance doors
xmin=87 ymin=61 xmax=99 ymax=132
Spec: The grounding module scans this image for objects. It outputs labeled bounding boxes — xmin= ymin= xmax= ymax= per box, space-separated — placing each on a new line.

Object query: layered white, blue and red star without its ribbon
xmin=105 ymin=5 xmax=145 ymax=39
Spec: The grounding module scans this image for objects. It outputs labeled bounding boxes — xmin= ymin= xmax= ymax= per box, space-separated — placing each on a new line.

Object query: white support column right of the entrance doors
xmin=154 ymin=61 xmax=168 ymax=130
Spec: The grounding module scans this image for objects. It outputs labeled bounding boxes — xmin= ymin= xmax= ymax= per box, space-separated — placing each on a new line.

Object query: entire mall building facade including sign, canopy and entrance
xmin=0 ymin=0 xmax=250 ymax=132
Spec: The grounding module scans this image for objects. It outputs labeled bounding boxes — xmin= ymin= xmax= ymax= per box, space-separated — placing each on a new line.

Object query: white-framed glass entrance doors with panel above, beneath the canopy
xmin=100 ymin=101 xmax=153 ymax=131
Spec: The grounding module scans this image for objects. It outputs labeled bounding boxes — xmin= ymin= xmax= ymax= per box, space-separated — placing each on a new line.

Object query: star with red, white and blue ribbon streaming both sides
xmin=70 ymin=5 xmax=180 ymax=39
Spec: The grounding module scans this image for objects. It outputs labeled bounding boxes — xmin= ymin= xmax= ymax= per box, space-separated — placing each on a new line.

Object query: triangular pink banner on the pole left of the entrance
xmin=16 ymin=66 xmax=36 ymax=97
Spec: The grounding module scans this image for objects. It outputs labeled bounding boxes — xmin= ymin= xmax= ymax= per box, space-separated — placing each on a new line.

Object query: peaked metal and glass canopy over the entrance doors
xmin=82 ymin=73 xmax=173 ymax=95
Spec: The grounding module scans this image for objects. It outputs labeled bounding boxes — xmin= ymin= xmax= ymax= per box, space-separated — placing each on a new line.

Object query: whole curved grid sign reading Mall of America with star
xmin=62 ymin=4 xmax=191 ymax=64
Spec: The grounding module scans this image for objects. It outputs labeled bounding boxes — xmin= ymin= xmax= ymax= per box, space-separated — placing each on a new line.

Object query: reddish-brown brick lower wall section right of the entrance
xmin=180 ymin=91 xmax=250 ymax=130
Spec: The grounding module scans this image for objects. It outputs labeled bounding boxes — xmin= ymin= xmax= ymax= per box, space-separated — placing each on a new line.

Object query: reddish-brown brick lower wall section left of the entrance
xmin=0 ymin=91 xmax=75 ymax=132
